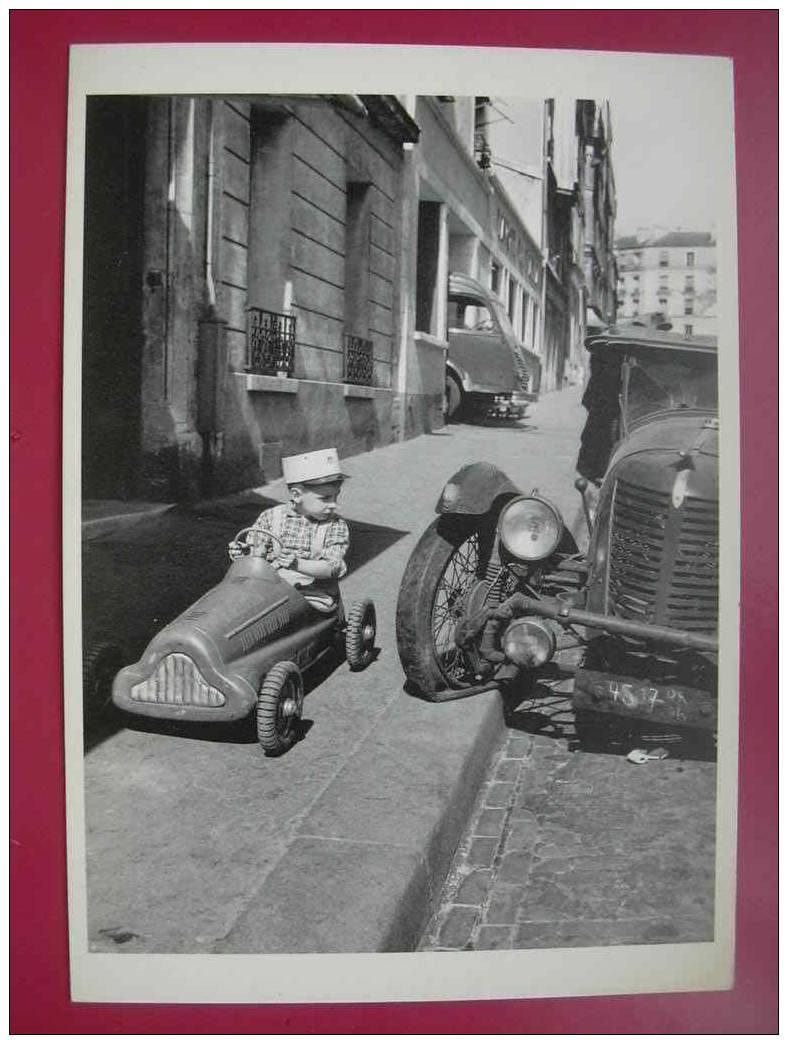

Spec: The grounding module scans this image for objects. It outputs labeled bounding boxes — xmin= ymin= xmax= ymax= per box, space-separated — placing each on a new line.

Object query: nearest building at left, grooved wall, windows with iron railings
xmin=82 ymin=96 xmax=418 ymax=500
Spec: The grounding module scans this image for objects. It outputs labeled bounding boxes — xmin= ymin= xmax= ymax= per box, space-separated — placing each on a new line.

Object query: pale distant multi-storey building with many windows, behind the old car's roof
xmin=616 ymin=230 xmax=717 ymax=336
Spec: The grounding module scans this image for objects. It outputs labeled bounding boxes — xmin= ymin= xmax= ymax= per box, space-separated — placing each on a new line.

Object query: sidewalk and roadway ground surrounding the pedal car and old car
xmin=83 ymin=389 xmax=714 ymax=953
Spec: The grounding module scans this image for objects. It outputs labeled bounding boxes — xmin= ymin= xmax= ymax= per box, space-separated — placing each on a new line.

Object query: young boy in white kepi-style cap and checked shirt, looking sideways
xmin=229 ymin=447 xmax=350 ymax=610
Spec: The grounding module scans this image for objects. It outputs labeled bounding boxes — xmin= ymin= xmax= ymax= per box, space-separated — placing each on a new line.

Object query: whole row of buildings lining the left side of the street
xmin=82 ymin=96 xmax=614 ymax=501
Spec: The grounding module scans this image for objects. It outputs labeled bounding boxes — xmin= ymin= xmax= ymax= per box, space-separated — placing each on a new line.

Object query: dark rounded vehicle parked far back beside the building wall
xmin=446 ymin=273 xmax=539 ymax=419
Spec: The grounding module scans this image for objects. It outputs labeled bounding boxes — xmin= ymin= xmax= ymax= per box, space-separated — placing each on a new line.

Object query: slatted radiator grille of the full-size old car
xmin=608 ymin=480 xmax=718 ymax=632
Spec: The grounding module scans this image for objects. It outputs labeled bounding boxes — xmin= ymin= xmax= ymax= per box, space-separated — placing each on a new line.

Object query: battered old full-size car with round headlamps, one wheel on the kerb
xmin=397 ymin=325 xmax=718 ymax=746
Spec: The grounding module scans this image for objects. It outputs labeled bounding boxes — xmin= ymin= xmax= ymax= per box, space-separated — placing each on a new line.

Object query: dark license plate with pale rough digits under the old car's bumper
xmin=573 ymin=669 xmax=716 ymax=728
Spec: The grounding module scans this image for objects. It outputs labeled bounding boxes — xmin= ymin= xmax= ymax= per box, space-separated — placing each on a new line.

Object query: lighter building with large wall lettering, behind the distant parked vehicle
xmin=397 ymin=96 xmax=541 ymax=438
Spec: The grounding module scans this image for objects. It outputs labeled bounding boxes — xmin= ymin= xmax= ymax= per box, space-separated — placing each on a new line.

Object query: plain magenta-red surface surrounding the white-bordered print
xmin=9 ymin=9 xmax=777 ymax=1035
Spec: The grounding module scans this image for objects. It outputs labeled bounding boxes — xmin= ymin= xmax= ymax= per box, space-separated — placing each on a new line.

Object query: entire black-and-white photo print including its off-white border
xmin=64 ymin=45 xmax=740 ymax=1002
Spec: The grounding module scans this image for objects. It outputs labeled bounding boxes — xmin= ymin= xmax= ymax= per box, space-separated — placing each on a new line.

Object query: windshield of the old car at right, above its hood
xmin=623 ymin=351 xmax=717 ymax=428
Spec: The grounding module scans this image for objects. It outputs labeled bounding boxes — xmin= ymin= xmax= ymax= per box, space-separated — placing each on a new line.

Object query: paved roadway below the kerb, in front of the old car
xmin=420 ymin=712 xmax=716 ymax=951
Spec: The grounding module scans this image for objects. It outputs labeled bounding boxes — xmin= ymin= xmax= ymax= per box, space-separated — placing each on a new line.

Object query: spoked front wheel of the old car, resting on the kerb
xmin=396 ymin=516 xmax=491 ymax=700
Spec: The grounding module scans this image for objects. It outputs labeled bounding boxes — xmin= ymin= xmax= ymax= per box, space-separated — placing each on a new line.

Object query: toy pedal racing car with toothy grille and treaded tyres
xmin=112 ymin=527 xmax=376 ymax=754
